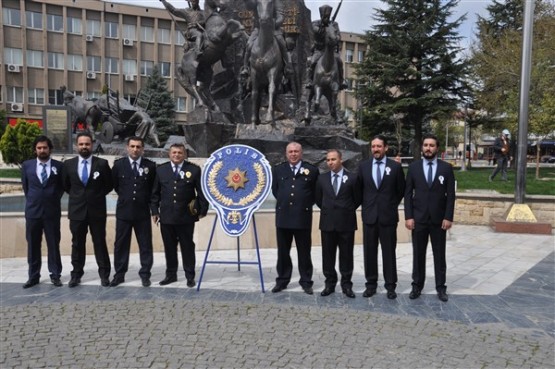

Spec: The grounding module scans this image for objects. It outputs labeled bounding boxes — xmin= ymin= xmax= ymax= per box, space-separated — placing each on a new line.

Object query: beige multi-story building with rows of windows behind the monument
xmin=0 ymin=0 xmax=364 ymax=126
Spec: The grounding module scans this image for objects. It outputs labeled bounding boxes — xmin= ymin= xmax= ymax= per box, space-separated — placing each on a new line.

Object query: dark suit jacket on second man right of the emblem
xmin=316 ymin=169 xmax=360 ymax=232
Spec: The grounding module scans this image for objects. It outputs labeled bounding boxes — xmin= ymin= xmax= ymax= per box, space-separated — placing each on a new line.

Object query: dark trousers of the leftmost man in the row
xmin=25 ymin=217 xmax=62 ymax=280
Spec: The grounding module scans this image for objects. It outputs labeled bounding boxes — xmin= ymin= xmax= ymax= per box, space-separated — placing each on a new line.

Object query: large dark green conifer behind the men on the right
xmin=356 ymin=0 xmax=469 ymax=157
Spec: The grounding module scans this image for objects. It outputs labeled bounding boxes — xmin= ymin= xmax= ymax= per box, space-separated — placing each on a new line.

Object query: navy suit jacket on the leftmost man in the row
xmin=21 ymin=159 xmax=64 ymax=219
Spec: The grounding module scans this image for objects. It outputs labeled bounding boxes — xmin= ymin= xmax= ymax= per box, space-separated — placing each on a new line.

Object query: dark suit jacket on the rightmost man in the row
xmin=405 ymin=159 xmax=455 ymax=224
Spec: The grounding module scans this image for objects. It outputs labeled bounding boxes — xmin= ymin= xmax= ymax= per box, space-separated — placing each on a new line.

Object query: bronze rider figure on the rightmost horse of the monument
xmin=305 ymin=5 xmax=347 ymax=90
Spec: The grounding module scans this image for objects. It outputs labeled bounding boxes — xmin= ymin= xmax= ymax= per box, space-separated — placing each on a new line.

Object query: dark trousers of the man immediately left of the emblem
xmin=160 ymin=223 xmax=196 ymax=280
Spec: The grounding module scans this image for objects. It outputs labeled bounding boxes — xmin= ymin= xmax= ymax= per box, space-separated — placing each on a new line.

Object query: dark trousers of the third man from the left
xmin=114 ymin=217 xmax=153 ymax=278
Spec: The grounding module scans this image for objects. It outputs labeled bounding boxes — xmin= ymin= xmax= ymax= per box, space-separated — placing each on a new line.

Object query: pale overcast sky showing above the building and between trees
xmin=112 ymin=0 xmax=491 ymax=47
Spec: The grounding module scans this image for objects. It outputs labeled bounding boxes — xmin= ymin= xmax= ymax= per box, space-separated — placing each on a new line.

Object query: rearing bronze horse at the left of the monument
xmin=176 ymin=4 xmax=247 ymax=112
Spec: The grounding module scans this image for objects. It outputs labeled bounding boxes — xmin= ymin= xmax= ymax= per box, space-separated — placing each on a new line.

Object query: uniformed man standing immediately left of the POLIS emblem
xmin=150 ymin=144 xmax=208 ymax=287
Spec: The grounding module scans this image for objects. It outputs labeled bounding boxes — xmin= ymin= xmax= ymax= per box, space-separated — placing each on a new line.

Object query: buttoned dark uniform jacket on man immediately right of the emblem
xmin=272 ymin=161 xmax=320 ymax=229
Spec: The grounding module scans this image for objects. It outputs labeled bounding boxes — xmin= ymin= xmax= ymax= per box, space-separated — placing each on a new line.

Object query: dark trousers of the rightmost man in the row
xmin=412 ymin=223 xmax=447 ymax=291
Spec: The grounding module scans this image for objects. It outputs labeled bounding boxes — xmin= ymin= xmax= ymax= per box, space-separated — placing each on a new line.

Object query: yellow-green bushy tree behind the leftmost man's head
xmin=0 ymin=119 xmax=42 ymax=166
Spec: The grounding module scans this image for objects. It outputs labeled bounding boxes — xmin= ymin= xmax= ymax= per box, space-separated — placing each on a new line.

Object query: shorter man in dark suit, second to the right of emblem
xmin=316 ymin=149 xmax=360 ymax=298
